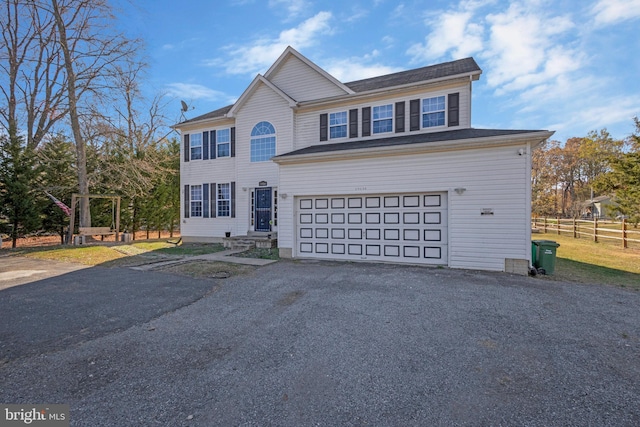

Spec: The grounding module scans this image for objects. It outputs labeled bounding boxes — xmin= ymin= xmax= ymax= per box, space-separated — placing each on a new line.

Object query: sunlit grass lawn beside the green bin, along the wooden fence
xmin=532 ymin=233 xmax=640 ymax=290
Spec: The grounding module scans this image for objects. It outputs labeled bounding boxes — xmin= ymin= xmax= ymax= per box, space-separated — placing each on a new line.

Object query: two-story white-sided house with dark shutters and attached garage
xmin=175 ymin=47 xmax=552 ymax=274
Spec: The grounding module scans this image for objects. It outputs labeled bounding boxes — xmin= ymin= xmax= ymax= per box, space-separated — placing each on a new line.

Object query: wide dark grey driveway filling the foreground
xmin=0 ymin=261 xmax=640 ymax=426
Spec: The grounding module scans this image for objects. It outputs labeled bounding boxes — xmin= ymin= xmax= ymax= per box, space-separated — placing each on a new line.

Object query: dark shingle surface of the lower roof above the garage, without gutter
xmin=274 ymin=128 xmax=546 ymax=159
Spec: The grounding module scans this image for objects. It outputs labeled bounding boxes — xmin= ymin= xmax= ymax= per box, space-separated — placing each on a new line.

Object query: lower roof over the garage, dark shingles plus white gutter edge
xmin=273 ymin=128 xmax=553 ymax=162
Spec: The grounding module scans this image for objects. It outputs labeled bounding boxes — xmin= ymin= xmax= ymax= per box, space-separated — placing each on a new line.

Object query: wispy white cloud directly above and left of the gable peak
xmin=215 ymin=12 xmax=332 ymax=74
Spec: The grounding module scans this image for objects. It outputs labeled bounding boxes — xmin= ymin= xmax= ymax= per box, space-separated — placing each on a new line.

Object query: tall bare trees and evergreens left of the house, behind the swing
xmin=0 ymin=0 xmax=179 ymax=244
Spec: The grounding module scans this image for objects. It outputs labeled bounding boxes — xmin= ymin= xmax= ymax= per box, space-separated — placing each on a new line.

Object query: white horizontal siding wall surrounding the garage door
xmin=278 ymin=147 xmax=531 ymax=271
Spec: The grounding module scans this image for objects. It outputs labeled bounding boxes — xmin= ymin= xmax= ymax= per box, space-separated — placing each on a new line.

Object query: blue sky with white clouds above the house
xmin=118 ymin=0 xmax=640 ymax=141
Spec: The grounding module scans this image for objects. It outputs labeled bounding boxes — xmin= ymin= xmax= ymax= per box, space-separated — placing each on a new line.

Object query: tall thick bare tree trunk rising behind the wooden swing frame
xmin=51 ymin=0 xmax=91 ymax=227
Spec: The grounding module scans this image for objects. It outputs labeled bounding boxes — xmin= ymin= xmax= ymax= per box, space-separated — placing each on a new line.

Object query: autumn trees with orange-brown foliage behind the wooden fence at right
xmin=531 ymin=117 xmax=640 ymax=225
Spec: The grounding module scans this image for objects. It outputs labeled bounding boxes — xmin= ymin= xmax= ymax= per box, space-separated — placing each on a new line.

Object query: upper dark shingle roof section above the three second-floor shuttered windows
xmin=345 ymin=58 xmax=482 ymax=93
